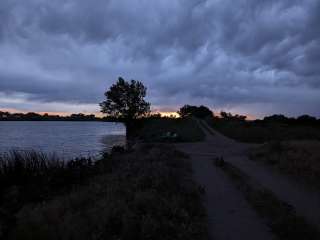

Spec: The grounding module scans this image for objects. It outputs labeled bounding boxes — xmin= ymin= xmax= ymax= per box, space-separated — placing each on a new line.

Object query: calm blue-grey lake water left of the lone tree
xmin=0 ymin=121 xmax=125 ymax=159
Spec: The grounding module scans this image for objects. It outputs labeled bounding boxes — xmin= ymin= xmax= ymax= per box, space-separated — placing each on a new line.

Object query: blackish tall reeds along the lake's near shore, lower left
xmin=0 ymin=151 xmax=95 ymax=239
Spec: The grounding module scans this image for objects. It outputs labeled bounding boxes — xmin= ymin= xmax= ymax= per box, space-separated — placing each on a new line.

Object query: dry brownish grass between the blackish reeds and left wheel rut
xmin=1 ymin=145 xmax=207 ymax=240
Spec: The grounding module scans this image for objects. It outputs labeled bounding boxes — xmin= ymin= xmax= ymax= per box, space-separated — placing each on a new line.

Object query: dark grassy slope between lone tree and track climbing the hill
xmin=137 ymin=118 xmax=205 ymax=142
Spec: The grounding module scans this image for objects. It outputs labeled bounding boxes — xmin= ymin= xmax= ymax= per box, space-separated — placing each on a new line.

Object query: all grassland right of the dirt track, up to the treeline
xmin=208 ymin=116 xmax=320 ymax=187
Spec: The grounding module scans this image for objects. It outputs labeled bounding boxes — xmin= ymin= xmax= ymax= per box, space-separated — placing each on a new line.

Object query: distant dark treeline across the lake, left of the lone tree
xmin=0 ymin=111 xmax=118 ymax=122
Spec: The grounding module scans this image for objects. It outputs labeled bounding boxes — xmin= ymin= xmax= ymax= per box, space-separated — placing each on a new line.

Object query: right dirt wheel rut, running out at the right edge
xmin=203 ymin=123 xmax=320 ymax=229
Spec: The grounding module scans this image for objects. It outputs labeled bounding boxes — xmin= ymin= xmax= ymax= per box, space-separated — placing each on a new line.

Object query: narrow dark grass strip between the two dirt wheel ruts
xmin=214 ymin=159 xmax=320 ymax=240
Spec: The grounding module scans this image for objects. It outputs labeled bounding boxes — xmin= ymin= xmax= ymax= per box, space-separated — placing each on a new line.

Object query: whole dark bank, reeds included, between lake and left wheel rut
xmin=0 ymin=117 xmax=206 ymax=239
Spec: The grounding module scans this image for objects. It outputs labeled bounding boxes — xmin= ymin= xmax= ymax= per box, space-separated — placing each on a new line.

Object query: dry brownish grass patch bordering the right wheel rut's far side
xmin=250 ymin=140 xmax=320 ymax=188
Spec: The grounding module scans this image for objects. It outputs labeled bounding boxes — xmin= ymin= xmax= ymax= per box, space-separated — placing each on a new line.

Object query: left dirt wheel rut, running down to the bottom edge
xmin=176 ymin=122 xmax=274 ymax=240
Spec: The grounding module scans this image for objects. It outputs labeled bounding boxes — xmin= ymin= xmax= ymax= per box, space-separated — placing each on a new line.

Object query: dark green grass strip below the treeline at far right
xmin=207 ymin=118 xmax=320 ymax=143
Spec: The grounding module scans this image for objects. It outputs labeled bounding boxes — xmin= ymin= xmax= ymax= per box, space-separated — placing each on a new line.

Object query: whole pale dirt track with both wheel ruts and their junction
xmin=177 ymin=120 xmax=320 ymax=239
